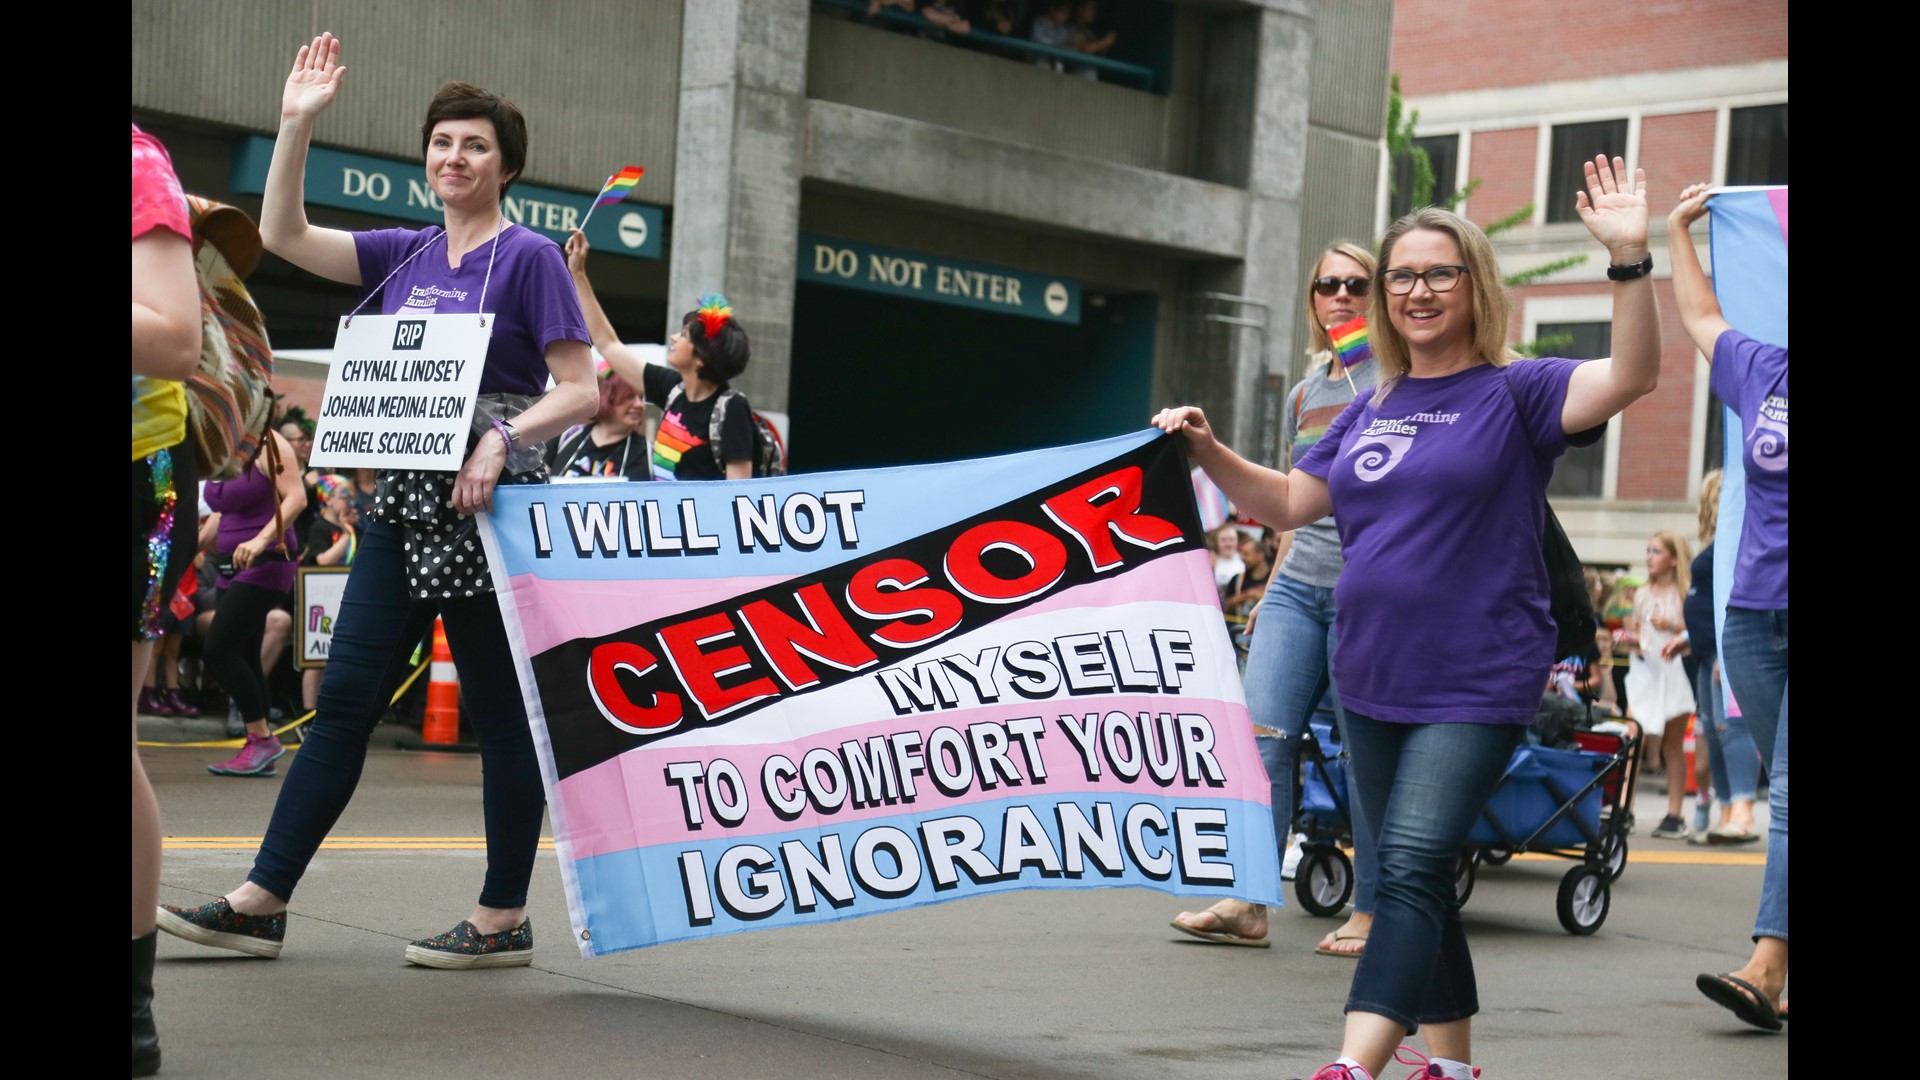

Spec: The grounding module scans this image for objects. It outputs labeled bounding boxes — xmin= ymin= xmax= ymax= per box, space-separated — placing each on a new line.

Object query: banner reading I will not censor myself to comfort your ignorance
xmin=480 ymin=430 xmax=1281 ymax=957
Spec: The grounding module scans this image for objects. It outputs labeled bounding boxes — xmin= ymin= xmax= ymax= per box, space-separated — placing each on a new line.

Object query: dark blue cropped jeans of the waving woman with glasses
xmin=1346 ymin=713 xmax=1526 ymax=1032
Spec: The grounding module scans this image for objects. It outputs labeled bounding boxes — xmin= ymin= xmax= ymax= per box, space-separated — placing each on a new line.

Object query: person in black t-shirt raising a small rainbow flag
xmin=566 ymin=229 xmax=755 ymax=480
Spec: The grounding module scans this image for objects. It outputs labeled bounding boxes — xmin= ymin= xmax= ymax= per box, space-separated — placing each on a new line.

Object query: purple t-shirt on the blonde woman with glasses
xmin=1296 ymin=359 xmax=1603 ymax=724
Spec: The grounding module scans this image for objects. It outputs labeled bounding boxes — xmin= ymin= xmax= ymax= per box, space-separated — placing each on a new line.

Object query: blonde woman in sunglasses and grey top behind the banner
xmin=1173 ymin=240 xmax=1375 ymax=959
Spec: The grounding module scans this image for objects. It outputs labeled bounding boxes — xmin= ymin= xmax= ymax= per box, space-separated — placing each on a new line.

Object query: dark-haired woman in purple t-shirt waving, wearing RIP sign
xmin=159 ymin=33 xmax=597 ymax=969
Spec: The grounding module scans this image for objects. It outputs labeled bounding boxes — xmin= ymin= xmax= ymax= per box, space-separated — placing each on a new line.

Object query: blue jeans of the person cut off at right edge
xmin=1720 ymin=607 xmax=1788 ymax=942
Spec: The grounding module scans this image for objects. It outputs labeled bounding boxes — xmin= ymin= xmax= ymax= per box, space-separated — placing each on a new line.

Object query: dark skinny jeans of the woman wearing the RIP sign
xmin=248 ymin=523 xmax=547 ymax=907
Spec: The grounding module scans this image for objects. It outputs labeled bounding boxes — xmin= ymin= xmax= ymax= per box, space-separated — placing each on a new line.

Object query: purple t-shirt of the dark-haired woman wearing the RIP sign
xmin=353 ymin=225 xmax=593 ymax=396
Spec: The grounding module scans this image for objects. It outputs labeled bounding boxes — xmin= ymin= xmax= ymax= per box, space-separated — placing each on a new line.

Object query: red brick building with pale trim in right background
xmin=1380 ymin=0 xmax=1788 ymax=565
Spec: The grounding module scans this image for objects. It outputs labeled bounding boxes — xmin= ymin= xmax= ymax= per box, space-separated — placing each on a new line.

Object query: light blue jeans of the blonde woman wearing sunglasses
xmin=1246 ymin=571 xmax=1379 ymax=915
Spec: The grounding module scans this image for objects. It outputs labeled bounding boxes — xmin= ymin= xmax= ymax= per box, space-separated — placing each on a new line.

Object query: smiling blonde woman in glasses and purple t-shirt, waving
xmin=1154 ymin=158 xmax=1661 ymax=1080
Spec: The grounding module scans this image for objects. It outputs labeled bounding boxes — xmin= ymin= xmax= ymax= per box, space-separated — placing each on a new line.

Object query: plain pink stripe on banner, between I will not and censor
xmin=511 ymin=575 xmax=787 ymax=655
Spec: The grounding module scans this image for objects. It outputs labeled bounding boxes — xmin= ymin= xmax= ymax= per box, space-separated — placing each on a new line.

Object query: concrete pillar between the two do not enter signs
xmin=666 ymin=0 xmax=808 ymax=411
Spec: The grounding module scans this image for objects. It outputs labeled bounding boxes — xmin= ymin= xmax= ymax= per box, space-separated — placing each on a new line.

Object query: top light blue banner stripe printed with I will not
xmin=490 ymin=429 xmax=1162 ymax=580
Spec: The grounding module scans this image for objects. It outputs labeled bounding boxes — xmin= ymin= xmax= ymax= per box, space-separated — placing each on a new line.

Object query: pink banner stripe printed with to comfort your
xmin=557 ymin=694 xmax=1267 ymax=859
